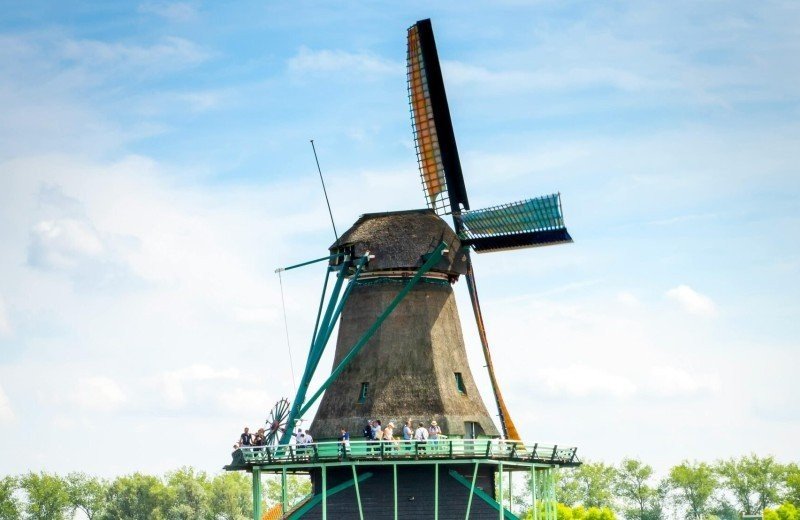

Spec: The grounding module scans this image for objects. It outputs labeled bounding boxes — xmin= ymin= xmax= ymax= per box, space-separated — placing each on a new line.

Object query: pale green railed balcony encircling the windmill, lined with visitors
xmin=225 ymin=439 xmax=580 ymax=470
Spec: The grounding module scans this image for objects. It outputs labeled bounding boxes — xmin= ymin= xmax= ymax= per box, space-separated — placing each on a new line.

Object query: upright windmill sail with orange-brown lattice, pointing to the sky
xmin=408 ymin=20 xmax=469 ymax=215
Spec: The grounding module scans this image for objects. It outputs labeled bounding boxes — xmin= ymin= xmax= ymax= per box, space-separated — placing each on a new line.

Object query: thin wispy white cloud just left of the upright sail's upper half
xmin=289 ymin=47 xmax=405 ymax=76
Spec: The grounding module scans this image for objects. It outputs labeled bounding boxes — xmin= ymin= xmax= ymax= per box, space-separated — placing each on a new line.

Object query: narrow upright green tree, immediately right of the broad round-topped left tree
xmin=167 ymin=467 xmax=213 ymax=520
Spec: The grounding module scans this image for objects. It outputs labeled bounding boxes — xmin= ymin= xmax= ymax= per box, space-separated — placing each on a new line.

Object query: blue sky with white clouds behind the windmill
xmin=0 ymin=0 xmax=800 ymax=476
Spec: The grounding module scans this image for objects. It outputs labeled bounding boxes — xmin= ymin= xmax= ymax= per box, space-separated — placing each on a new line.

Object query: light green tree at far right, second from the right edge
xmin=714 ymin=454 xmax=786 ymax=515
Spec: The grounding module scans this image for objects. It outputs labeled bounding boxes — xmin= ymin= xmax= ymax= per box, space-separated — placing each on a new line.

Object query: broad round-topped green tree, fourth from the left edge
xmin=103 ymin=473 xmax=170 ymax=520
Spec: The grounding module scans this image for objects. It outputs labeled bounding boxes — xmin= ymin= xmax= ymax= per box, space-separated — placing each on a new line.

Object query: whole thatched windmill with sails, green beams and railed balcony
xmin=228 ymin=20 xmax=579 ymax=519
